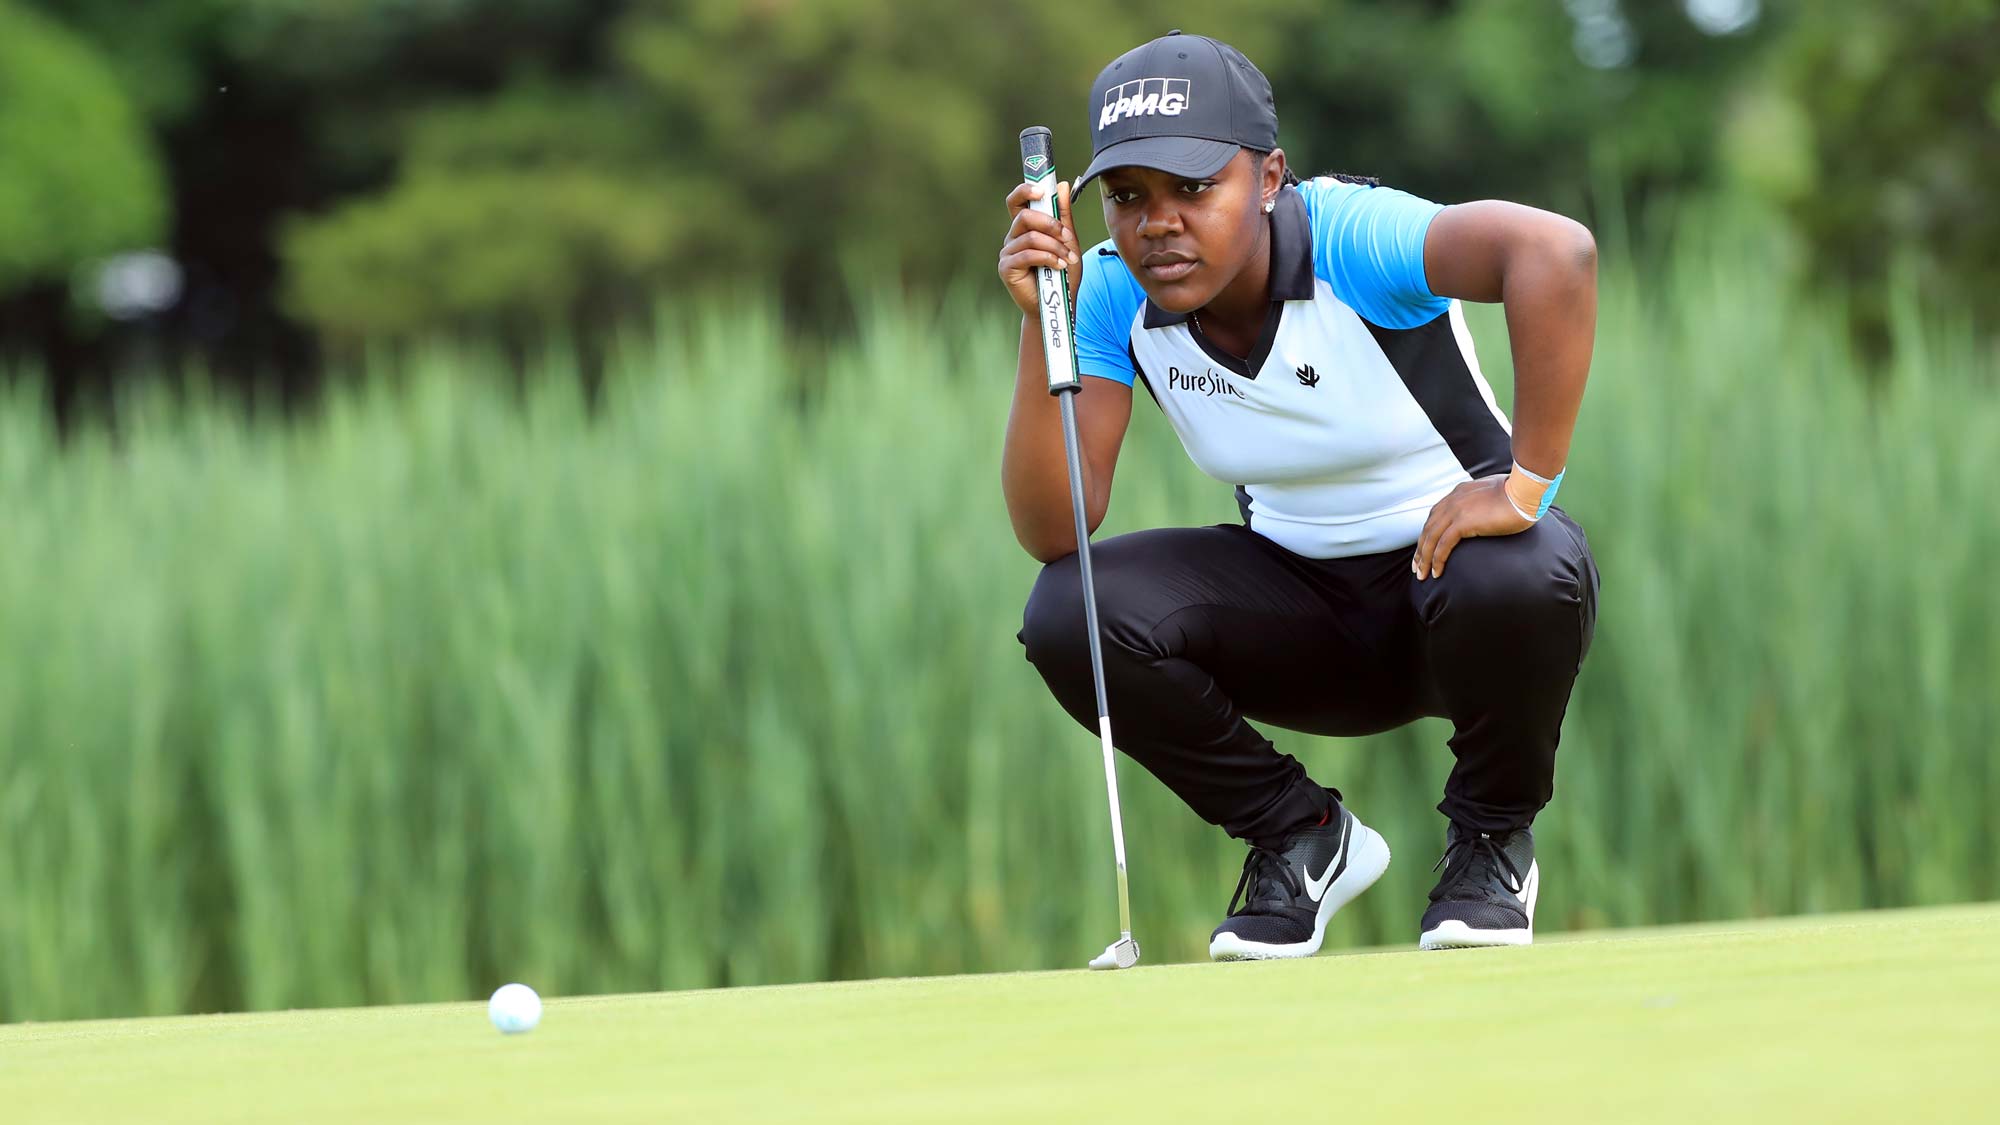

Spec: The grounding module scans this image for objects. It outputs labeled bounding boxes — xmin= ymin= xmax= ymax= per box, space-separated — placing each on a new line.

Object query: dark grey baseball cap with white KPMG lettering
xmin=1076 ymin=28 xmax=1278 ymax=188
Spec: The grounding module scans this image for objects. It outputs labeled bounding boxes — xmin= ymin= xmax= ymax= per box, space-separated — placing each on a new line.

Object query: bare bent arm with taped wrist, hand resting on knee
xmin=1412 ymin=200 xmax=1598 ymax=581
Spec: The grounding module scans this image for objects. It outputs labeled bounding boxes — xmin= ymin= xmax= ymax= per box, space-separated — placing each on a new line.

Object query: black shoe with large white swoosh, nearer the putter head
xmin=1208 ymin=803 xmax=1388 ymax=961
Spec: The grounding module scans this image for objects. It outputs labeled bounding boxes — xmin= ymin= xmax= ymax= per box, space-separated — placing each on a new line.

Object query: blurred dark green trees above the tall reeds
xmin=0 ymin=0 xmax=2000 ymax=406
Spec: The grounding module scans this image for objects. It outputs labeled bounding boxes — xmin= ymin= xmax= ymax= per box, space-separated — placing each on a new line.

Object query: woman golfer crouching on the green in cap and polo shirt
xmin=1000 ymin=32 xmax=1598 ymax=948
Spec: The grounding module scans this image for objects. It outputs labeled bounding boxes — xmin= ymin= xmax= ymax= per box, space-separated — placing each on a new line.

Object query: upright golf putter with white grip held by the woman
xmin=1020 ymin=124 xmax=1138 ymax=969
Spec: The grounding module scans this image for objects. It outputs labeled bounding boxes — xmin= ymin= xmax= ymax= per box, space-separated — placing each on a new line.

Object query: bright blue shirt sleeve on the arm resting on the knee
xmin=1300 ymin=176 xmax=1452 ymax=328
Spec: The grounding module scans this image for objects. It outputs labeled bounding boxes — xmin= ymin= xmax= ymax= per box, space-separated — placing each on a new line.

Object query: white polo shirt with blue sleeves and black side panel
xmin=1076 ymin=176 xmax=1514 ymax=558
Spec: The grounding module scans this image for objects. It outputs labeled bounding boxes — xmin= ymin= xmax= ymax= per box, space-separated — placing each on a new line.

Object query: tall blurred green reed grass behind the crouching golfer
xmin=0 ymin=223 xmax=2000 ymax=1019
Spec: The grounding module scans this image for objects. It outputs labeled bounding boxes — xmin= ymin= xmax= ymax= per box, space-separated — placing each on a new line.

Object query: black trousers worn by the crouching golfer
xmin=1018 ymin=506 xmax=1598 ymax=847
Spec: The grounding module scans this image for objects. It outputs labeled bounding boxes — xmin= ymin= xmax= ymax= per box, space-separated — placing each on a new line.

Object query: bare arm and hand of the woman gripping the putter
xmin=1000 ymin=176 xmax=1132 ymax=563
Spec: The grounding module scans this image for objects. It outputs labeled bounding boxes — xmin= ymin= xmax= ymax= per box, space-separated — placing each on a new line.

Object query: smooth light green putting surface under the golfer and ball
xmin=0 ymin=905 xmax=2000 ymax=1125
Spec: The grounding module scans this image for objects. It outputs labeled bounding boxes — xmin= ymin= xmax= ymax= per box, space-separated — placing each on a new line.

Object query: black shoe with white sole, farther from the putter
xmin=1418 ymin=823 xmax=1542 ymax=949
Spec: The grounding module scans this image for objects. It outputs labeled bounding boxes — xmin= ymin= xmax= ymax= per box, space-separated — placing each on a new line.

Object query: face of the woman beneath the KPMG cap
xmin=1098 ymin=148 xmax=1284 ymax=312
